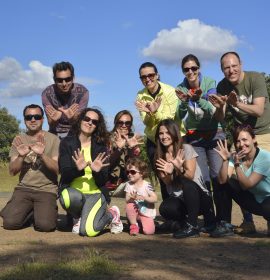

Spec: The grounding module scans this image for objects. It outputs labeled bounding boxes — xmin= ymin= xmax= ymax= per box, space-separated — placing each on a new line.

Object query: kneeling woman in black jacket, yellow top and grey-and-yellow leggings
xmin=59 ymin=108 xmax=123 ymax=236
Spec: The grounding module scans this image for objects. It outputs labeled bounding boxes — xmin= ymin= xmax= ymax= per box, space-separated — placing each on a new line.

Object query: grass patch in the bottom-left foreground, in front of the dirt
xmin=0 ymin=249 xmax=120 ymax=280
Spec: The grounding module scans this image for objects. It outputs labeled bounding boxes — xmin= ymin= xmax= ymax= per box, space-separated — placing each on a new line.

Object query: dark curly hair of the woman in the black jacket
xmin=71 ymin=108 xmax=109 ymax=145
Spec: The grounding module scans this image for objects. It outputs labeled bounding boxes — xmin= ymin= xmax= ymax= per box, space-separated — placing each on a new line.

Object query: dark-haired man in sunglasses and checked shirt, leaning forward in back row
xmin=42 ymin=61 xmax=89 ymax=138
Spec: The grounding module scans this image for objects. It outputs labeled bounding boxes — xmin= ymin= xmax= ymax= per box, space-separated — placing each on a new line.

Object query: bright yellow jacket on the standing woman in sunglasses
xmin=137 ymin=82 xmax=181 ymax=143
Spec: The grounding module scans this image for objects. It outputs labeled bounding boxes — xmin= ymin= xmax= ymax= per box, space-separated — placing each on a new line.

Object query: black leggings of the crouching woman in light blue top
xmin=217 ymin=179 xmax=270 ymax=222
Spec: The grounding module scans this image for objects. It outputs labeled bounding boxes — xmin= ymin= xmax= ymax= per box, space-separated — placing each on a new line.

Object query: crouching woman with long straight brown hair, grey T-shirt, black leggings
xmin=155 ymin=119 xmax=215 ymax=238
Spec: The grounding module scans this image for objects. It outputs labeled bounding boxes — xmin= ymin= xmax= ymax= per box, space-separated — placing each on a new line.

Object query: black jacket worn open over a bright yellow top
xmin=58 ymin=135 xmax=110 ymax=203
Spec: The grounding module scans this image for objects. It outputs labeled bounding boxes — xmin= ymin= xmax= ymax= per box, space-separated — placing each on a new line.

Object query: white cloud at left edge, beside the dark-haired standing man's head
xmin=0 ymin=57 xmax=53 ymax=97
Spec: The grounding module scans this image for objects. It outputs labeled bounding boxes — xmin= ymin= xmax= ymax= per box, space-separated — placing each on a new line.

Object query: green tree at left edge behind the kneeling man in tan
xmin=0 ymin=107 xmax=20 ymax=162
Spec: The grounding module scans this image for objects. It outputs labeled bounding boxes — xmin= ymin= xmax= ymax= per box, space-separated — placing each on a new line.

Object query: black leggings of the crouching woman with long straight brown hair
xmin=159 ymin=179 xmax=215 ymax=226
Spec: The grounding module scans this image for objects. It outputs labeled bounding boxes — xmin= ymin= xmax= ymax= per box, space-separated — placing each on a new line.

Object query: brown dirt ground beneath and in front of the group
xmin=0 ymin=195 xmax=270 ymax=280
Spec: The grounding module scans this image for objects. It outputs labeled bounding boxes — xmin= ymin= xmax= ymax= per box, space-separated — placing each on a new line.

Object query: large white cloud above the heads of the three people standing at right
xmin=142 ymin=19 xmax=241 ymax=64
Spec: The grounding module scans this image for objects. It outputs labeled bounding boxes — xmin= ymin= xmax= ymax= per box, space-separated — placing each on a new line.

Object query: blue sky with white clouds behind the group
xmin=0 ymin=0 xmax=270 ymax=131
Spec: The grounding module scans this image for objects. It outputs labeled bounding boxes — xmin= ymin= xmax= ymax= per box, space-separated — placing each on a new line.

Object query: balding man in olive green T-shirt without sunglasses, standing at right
xmin=210 ymin=52 xmax=270 ymax=233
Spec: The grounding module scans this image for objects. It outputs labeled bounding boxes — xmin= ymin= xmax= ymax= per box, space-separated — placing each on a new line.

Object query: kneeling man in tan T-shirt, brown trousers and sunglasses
xmin=0 ymin=104 xmax=60 ymax=232
